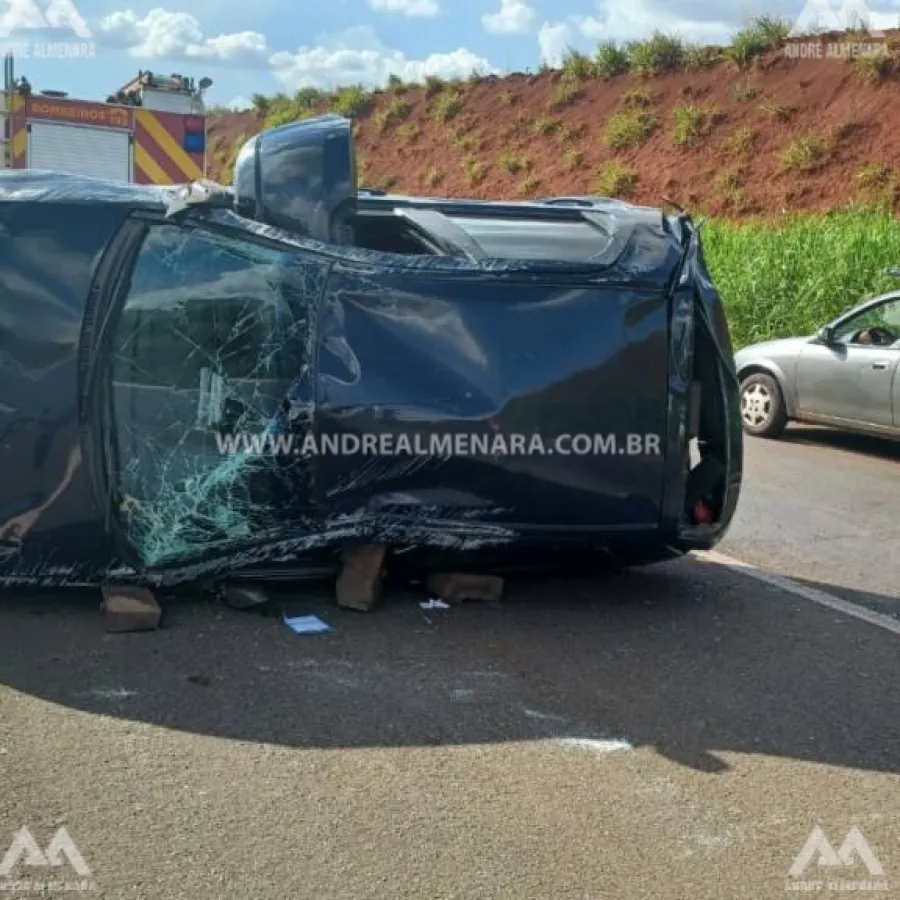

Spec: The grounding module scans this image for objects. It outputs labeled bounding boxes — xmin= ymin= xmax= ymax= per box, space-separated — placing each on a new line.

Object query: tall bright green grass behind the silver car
xmin=703 ymin=210 xmax=900 ymax=349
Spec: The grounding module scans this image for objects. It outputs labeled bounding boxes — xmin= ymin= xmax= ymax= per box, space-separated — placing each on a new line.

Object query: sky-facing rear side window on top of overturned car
xmin=449 ymin=216 xmax=612 ymax=262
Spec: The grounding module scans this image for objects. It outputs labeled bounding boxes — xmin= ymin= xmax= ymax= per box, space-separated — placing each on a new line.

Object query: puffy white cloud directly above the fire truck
xmin=99 ymin=9 xmax=269 ymax=67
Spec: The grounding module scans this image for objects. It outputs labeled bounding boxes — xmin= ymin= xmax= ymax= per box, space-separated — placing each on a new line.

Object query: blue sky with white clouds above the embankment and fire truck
xmin=0 ymin=0 xmax=900 ymax=105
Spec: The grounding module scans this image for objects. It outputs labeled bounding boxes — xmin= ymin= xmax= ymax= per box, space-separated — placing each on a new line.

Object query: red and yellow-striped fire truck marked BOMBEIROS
xmin=0 ymin=54 xmax=212 ymax=184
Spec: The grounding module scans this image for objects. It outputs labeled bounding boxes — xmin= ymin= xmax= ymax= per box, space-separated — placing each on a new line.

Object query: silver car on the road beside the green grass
xmin=735 ymin=291 xmax=900 ymax=439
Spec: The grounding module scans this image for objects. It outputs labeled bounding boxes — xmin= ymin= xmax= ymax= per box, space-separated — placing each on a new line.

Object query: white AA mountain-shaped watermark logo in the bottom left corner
xmin=0 ymin=826 xmax=97 ymax=894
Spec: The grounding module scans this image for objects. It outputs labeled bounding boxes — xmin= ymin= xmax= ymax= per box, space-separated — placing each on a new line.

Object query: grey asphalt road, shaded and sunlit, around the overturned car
xmin=0 ymin=424 xmax=900 ymax=900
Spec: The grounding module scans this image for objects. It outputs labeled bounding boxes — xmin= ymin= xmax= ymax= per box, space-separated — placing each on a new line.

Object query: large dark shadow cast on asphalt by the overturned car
xmin=0 ymin=560 xmax=900 ymax=773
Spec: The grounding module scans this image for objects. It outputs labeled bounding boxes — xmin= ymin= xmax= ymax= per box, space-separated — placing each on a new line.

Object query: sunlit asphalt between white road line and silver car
xmin=721 ymin=426 xmax=900 ymax=616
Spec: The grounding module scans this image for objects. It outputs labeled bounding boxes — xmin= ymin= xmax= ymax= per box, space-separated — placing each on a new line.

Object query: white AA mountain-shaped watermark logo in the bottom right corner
xmin=785 ymin=825 xmax=890 ymax=893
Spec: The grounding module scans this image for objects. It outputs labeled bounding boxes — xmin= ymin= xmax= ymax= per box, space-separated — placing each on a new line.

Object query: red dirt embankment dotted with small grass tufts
xmin=210 ymin=39 xmax=900 ymax=217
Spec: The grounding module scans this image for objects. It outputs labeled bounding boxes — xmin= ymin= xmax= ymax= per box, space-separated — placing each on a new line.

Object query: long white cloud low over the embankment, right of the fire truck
xmin=271 ymin=26 xmax=497 ymax=90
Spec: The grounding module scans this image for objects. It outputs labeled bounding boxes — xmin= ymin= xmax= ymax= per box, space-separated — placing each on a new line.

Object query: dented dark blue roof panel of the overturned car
xmin=317 ymin=254 xmax=669 ymax=540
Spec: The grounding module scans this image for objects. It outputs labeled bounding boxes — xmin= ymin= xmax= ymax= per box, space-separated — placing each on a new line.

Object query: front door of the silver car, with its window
xmin=797 ymin=297 xmax=900 ymax=428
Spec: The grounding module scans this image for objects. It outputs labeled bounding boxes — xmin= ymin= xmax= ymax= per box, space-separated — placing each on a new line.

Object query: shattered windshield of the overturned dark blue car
xmin=104 ymin=221 xmax=324 ymax=570
